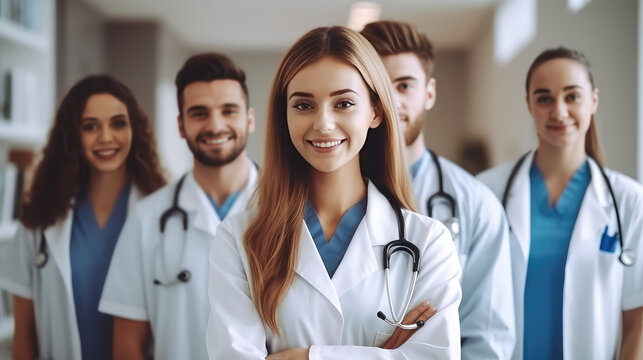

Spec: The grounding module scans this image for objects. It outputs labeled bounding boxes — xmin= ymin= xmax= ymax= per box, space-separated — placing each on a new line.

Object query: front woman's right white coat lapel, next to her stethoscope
xmin=333 ymin=181 xmax=392 ymax=297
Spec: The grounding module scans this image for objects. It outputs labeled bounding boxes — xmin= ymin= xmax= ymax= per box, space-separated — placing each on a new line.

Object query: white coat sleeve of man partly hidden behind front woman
xmin=460 ymin=190 xmax=516 ymax=359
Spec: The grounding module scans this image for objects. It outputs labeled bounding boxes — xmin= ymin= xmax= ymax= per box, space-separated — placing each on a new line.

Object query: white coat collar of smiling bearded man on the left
xmin=180 ymin=158 xmax=258 ymax=236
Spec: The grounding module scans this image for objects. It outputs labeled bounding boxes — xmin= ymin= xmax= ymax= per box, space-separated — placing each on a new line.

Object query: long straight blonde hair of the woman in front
xmin=244 ymin=26 xmax=415 ymax=335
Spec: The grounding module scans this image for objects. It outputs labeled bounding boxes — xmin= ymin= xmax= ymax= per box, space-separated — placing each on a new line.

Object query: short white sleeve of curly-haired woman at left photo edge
xmin=0 ymin=224 xmax=35 ymax=299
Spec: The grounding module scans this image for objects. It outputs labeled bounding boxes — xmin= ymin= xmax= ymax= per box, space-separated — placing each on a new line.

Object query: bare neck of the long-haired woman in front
xmin=308 ymin=157 xmax=366 ymax=231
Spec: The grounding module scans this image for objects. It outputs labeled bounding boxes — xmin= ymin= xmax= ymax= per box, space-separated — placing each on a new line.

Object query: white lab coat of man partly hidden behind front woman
xmin=412 ymin=155 xmax=516 ymax=360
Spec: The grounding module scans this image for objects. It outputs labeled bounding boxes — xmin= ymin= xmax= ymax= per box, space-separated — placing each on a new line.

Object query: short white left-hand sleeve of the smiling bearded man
xmin=98 ymin=213 xmax=148 ymax=321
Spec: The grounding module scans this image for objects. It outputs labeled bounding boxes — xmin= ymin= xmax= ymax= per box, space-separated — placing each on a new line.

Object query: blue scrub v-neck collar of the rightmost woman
xmin=529 ymin=158 xmax=591 ymax=215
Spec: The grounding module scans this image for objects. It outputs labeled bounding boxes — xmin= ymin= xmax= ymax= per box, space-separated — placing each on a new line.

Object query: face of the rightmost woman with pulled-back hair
xmin=527 ymin=58 xmax=598 ymax=148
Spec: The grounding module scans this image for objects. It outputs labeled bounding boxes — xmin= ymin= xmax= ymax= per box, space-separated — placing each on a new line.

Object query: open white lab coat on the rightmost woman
xmin=480 ymin=152 xmax=643 ymax=360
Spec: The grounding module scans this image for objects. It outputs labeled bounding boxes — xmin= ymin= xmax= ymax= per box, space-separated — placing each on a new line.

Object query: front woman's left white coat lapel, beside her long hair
xmin=295 ymin=225 xmax=342 ymax=314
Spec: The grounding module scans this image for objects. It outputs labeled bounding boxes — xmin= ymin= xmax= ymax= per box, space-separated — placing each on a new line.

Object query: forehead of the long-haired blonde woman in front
xmin=287 ymin=57 xmax=368 ymax=96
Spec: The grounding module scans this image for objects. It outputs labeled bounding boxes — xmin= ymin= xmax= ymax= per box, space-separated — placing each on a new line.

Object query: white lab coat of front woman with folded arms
xmin=207 ymin=182 xmax=461 ymax=360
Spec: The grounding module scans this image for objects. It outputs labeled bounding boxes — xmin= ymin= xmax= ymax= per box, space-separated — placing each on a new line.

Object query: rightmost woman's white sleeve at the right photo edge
xmin=617 ymin=184 xmax=643 ymax=311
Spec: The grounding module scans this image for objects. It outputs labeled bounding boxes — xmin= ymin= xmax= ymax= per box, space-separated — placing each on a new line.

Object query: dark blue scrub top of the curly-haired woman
xmin=70 ymin=185 xmax=130 ymax=359
